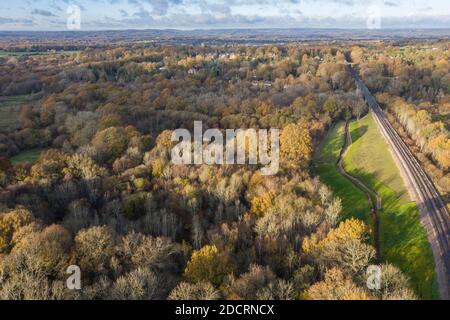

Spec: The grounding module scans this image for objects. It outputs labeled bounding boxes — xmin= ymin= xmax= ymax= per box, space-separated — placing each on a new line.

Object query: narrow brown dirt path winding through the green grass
xmin=336 ymin=122 xmax=381 ymax=261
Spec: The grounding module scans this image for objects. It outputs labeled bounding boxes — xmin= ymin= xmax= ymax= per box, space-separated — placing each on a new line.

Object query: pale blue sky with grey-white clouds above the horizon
xmin=0 ymin=0 xmax=450 ymax=31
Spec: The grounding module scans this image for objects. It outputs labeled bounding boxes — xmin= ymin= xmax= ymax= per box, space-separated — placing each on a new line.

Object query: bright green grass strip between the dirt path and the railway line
xmin=344 ymin=115 xmax=439 ymax=299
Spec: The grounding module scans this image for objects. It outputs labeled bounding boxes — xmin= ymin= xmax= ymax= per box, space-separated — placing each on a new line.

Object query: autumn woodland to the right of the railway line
xmin=351 ymin=42 xmax=450 ymax=204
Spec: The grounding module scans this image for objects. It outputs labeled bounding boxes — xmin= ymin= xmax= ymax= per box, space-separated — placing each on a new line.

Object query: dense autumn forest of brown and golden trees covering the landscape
xmin=0 ymin=42 xmax=450 ymax=300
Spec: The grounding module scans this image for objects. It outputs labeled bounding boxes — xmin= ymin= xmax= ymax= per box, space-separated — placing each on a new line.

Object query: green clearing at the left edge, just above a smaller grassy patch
xmin=0 ymin=95 xmax=28 ymax=132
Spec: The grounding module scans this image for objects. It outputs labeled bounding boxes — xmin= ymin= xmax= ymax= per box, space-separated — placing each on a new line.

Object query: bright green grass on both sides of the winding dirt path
xmin=315 ymin=115 xmax=439 ymax=299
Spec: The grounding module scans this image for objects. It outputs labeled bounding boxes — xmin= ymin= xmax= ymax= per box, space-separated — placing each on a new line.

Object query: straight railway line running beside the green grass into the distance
xmin=349 ymin=66 xmax=450 ymax=300
